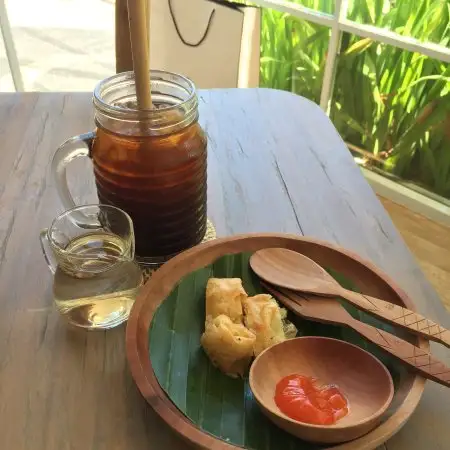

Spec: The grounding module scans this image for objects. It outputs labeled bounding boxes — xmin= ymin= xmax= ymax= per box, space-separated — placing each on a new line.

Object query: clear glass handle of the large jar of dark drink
xmin=51 ymin=131 xmax=95 ymax=210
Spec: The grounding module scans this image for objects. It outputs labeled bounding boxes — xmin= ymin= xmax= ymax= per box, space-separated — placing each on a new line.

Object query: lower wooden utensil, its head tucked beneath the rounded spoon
xmin=262 ymin=283 xmax=450 ymax=387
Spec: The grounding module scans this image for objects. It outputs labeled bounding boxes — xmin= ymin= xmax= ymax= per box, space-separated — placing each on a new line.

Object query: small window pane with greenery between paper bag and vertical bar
xmin=260 ymin=9 xmax=330 ymax=103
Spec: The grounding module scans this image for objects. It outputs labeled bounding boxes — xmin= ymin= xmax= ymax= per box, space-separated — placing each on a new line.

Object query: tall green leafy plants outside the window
xmin=261 ymin=0 xmax=450 ymax=197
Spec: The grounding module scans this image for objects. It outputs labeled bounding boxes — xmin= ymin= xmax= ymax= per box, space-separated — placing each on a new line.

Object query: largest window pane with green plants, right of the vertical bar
xmin=331 ymin=33 xmax=450 ymax=198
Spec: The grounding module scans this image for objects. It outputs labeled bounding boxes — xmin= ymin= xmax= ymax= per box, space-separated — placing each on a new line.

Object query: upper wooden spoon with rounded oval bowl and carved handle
xmin=250 ymin=248 xmax=450 ymax=348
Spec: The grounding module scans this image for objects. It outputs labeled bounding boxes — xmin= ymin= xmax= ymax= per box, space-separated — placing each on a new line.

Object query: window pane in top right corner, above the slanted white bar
xmin=347 ymin=0 xmax=450 ymax=46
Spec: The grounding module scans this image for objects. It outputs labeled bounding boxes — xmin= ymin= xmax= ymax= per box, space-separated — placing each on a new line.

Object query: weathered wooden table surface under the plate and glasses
xmin=0 ymin=89 xmax=450 ymax=450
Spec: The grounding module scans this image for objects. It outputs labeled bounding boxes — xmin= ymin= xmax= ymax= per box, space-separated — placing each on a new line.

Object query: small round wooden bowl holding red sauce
xmin=250 ymin=336 xmax=394 ymax=444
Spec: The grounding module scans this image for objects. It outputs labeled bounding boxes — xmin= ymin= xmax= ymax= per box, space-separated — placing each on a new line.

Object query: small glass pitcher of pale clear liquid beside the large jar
xmin=40 ymin=205 xmax=143 ymax=329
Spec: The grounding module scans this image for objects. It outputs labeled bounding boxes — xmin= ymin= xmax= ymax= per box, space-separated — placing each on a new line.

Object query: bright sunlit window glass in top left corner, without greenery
xmin=0 ymin=0 xmax=115 ymax=91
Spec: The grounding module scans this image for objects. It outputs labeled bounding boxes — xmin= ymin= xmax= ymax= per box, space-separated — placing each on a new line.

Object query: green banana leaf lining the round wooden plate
xmin=149 ymin=253 xmax=404 ymax=450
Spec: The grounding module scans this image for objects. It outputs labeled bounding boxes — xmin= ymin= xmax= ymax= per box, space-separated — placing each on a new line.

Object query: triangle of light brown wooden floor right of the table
xmin=380 ymin=198 xmax=450 ymax=311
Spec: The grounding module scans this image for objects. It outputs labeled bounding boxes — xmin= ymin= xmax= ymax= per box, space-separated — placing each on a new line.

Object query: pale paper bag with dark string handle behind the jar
xmin=150 ymin=0 xmax=260 ymax=89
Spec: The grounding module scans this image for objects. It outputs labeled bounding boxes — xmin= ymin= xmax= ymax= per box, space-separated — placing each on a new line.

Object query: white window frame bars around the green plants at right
xmin=252 ymin=0 xmax=450 ymax=221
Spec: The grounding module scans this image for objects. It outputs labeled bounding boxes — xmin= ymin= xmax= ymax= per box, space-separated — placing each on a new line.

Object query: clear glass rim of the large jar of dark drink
xmin=93 ymin=69 xmax=197 ymax=119
